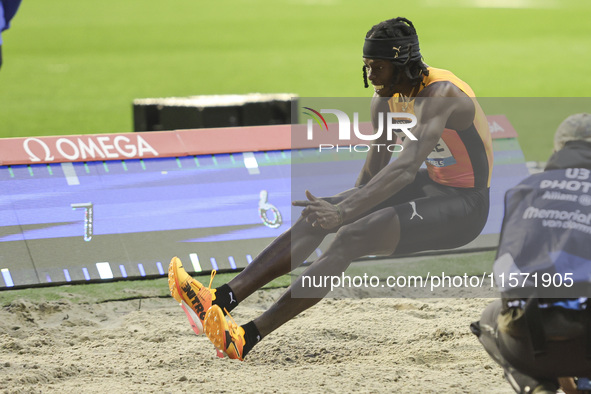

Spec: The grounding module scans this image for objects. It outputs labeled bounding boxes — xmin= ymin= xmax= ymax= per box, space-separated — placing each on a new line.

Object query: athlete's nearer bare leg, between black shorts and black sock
xmin=254 ymin=208 xmax=400 ymax=337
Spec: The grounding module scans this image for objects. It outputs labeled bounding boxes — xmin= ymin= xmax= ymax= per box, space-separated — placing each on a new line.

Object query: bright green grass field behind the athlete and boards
xmin=0 ymin=0 xmax=591 ymax=160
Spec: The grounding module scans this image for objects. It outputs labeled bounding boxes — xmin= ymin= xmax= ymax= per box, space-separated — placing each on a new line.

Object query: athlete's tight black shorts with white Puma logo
xmin=372 ymin=169 xmax=489 ymax=255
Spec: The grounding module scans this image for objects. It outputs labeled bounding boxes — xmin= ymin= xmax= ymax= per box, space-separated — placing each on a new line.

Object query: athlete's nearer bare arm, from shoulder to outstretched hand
xmin=294 ymin=82 xmax=475 ymax=229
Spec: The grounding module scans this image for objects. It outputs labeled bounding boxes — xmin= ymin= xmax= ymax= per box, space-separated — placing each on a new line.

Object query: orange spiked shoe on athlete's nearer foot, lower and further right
xmin=203 ymin=305 xmax=246 ymax=361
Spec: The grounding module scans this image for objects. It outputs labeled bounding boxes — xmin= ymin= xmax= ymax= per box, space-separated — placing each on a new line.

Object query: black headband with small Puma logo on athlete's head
xmin=363 ymin=34 xmax=421 ymax=65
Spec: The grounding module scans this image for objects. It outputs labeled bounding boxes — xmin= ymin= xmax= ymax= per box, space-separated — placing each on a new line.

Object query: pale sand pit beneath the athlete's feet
xmin=0 ymin=289 xmax=512 ymax=394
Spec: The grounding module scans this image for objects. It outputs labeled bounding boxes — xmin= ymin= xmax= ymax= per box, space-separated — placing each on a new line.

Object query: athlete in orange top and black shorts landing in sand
xmin=169 ymin=18 xmax=492 ymax=360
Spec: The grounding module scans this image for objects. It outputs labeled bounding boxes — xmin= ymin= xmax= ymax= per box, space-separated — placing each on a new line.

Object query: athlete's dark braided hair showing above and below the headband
xmin=363 ymin=17 xmax=429 ymax=88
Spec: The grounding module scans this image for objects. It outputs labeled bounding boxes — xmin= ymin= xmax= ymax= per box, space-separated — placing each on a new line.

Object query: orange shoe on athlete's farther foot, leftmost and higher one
xmin=168 ymin=257 xmax=215 ymax=335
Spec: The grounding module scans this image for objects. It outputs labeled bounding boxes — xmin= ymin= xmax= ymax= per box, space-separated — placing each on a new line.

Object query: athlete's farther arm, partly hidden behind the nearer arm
xmin=355 ymin=93 xmax=392 ymax=187
